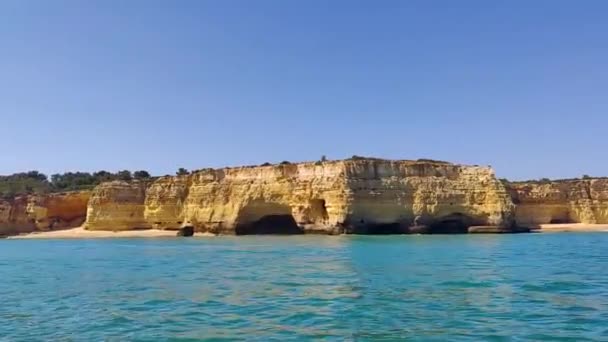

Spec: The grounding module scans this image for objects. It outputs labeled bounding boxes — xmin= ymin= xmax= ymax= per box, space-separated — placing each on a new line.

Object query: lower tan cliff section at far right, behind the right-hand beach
xmin=508 ymin=178 xmax=608 ymax=225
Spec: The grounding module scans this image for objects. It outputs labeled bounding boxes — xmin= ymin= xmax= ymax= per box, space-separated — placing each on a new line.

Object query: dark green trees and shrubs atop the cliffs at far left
xmin=0 ymin=170 xmax=151 ymax=198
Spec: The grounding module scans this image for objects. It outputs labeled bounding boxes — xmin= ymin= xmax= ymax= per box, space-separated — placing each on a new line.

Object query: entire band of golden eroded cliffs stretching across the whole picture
xmin=0 ymin=159 xmax=608 ymax=236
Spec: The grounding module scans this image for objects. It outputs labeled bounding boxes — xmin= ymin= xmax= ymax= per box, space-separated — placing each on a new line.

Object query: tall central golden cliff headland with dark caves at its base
xmin=86 ymin=159 xmax=514 ymax=234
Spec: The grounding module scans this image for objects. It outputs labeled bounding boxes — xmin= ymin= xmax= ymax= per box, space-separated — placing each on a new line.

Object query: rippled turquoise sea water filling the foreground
xmin=0 ymin=233 xmax=608 ymax=341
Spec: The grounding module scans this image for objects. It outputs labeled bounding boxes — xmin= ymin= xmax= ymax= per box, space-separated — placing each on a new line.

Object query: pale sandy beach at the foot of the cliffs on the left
xmin=8 ymin=227 xmax=214 ymax=239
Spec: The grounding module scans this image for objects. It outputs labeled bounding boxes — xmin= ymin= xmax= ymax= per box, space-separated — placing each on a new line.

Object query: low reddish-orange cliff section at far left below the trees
xmin=0 ymin=191 xmax=90 ymax=235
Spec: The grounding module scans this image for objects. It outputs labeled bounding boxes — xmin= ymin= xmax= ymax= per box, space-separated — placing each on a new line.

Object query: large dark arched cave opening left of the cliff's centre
xmin=235 ymin=201 xmax=304 ymax=235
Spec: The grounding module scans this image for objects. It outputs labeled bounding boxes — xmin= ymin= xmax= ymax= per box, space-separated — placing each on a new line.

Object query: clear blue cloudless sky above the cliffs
xmin=0 ymin=0 xmax=608 ymax=179
